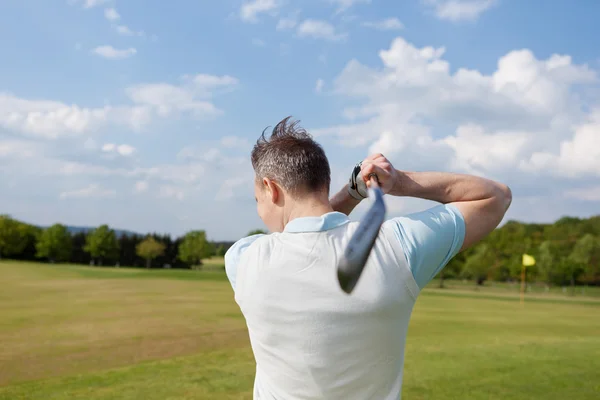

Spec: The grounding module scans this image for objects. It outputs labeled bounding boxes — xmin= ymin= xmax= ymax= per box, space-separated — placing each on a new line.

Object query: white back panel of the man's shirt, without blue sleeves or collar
xmin=235 ymin=223 xmax=418 ymax=399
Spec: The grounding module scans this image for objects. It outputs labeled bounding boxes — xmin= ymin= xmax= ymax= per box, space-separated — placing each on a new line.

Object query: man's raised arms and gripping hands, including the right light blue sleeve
xmin=332 ymin=154 xmax=512 ymax=289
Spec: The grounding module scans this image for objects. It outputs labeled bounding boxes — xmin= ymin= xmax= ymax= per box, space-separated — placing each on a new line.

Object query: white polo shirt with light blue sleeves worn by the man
xmin=225 ymin=205 xmax=465 ymax=400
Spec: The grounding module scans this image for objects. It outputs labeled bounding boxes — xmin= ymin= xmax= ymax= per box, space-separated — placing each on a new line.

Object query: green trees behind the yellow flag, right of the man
xmin=438 ymin=215 xmax=600 ymax=288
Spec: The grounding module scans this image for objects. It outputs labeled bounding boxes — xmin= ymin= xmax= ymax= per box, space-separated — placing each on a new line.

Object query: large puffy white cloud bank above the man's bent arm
xmin=312 ymin=38 xmax=600 ymax=190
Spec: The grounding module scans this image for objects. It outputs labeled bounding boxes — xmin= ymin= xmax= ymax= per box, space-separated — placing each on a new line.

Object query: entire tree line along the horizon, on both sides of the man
xmin=0 ymin=215 xmax=600 ymax=287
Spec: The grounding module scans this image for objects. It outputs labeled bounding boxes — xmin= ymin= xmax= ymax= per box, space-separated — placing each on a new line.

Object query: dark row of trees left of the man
xmin=0 ymin=215 xmax=248 ymax=268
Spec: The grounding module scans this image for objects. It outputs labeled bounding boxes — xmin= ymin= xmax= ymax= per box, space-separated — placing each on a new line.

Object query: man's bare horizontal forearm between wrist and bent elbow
xmin=389 ymin=171 xmax=510 ymax=207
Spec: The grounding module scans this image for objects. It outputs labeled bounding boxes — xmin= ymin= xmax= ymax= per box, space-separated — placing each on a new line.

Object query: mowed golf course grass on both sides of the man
xmin=0 ymin=260 xmax=600 ymax=400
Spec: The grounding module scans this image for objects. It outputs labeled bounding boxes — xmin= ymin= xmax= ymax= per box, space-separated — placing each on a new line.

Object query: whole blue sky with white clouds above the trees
xmin=0 ymin=0 xmax=600 ymax=240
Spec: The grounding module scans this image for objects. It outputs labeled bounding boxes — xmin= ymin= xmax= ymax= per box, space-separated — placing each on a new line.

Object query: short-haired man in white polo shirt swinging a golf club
xmin=225 ymin=117 xmax=511 ymax=400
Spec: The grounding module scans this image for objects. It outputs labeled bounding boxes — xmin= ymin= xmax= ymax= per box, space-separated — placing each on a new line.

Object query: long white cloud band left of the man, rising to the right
xmin=0 ymin=74 xmax=238 ymax=139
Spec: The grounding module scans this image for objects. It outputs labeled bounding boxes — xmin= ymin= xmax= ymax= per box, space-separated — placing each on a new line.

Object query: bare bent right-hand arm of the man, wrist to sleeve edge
xmin=392 ymin=167 xmax=512 ymax=251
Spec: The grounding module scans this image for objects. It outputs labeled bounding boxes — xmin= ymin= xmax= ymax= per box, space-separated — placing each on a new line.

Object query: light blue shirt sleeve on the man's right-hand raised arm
xmin=386 ymin=204 xmax=465 ymax=289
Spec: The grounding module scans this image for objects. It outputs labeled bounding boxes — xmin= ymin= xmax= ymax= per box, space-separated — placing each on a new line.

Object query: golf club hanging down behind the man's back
xmin=337 ymin=174 xmax=386 ymax=294
